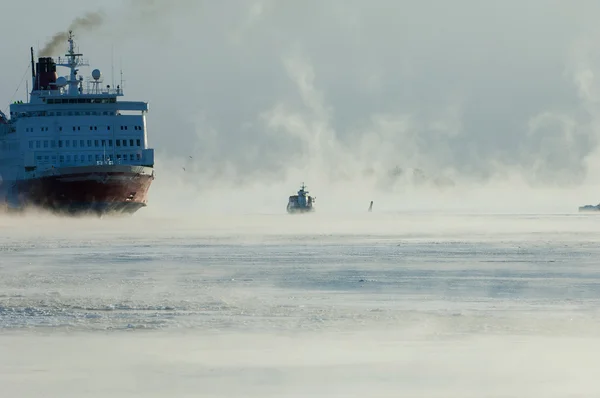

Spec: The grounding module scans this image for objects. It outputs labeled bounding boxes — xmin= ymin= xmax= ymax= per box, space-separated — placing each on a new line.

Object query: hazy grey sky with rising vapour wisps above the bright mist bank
xmin=0 ymin=0 xmax=600 ymax=190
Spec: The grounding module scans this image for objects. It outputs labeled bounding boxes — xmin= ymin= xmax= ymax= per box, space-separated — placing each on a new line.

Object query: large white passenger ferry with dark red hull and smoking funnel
xmin=0 ymin=32 xmax=154 ymax=216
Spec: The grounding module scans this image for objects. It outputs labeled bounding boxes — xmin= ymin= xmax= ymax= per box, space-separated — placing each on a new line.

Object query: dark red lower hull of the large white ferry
xmin=7 ymin=165 xmax=154 ymax=216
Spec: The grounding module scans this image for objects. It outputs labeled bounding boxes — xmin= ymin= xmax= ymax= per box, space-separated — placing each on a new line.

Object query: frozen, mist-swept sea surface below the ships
xmin=0 ymin=210 xmax=600 ymax=398
